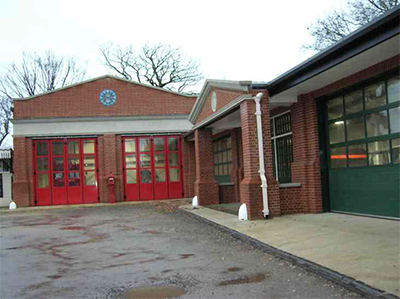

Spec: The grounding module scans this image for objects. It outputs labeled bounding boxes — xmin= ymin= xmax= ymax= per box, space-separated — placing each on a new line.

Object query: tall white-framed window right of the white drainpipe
xmin=271 ymin=112 xmax=292 ymax=183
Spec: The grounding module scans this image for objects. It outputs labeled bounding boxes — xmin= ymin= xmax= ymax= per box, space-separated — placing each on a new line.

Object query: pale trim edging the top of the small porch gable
xmin=189 ymin=79 xmax=251 ymax=124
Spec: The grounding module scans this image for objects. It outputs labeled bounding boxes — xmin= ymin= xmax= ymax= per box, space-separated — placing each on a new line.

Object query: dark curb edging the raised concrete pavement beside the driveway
xmin=180 ymin=208 xmax=400 ymax=299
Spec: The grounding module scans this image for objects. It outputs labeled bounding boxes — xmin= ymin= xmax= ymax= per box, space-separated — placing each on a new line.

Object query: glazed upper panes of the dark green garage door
xmin=327 ymin=75 xmax=400 ymax=169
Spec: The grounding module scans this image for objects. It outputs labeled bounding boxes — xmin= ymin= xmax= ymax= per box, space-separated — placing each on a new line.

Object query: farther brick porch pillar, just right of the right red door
xmin=194 ymin=129 xmax=219 ymax=206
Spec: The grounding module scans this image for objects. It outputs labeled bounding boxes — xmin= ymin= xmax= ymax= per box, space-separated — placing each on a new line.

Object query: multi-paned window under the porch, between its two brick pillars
xmin=213 ymin=136 xmax=232 ymax=183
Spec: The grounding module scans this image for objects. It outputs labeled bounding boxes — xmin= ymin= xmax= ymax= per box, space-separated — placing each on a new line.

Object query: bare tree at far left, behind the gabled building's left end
xmin=0 ymin=51 xmax=86 ymax=146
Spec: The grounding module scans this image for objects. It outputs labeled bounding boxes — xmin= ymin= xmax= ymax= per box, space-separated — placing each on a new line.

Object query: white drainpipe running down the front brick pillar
xmin=254 ymin=92 xmax=269 ymax=218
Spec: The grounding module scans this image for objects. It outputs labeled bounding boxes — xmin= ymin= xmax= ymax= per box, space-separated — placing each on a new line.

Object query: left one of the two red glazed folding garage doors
xmin=34 ymin=138 xmax=99 ymax=206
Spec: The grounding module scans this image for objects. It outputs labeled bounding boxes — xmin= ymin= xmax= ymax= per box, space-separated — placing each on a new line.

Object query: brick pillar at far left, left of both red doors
xmin=13 ymin=137 xmax=35 ymax=207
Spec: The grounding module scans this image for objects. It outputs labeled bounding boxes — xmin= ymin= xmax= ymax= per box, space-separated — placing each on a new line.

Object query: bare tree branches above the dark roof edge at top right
xmin=302 ymin=0 xmax=400 ymax=51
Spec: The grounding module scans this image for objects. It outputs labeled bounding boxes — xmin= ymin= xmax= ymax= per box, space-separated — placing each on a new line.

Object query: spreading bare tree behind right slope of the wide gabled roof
xmin=100 ymin=44 xmax=203 ymax=92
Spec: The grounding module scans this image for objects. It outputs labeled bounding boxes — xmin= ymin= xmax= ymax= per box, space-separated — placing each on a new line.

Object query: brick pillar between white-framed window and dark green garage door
xmin=291 ymin=95 xmax=322 ymax=213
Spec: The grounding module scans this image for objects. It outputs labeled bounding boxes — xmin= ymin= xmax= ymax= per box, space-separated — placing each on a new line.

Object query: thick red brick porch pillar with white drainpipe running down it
xmin=240 ymin=97 xmax=280 ymax=220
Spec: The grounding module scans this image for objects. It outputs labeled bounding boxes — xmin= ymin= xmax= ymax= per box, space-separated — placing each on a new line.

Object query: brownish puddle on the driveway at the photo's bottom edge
xmin=121 ymin=286 xmax=185 ymax=298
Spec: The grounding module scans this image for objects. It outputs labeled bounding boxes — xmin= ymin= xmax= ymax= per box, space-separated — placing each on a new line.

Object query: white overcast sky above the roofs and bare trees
xmin=0 ymin=0 xmax=347 ymax=90
